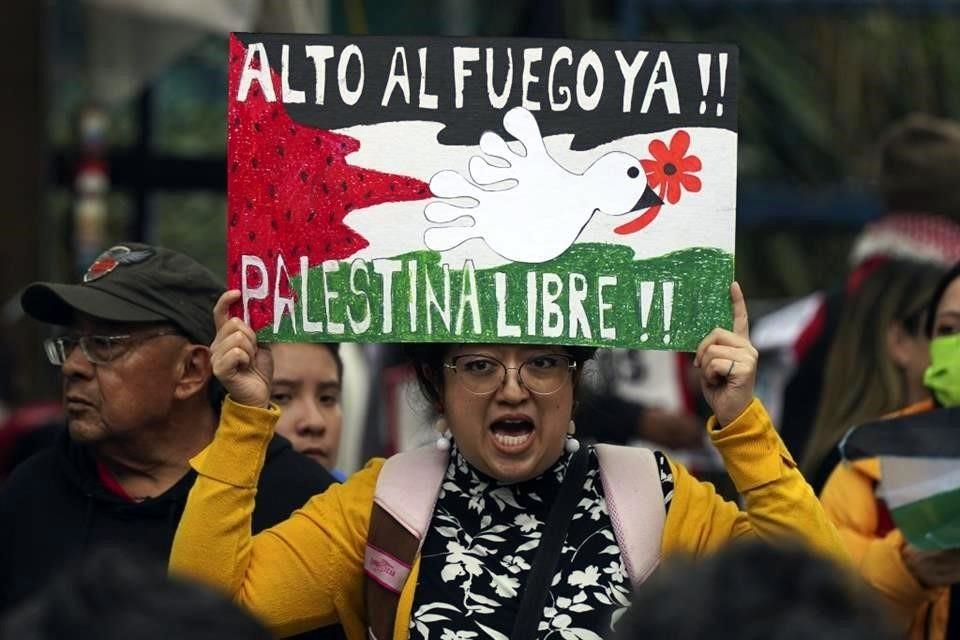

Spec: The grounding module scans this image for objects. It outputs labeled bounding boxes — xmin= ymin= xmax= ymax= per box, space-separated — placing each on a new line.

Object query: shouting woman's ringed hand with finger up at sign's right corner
xmin=693 ymin=282 xmax=757 ymax=427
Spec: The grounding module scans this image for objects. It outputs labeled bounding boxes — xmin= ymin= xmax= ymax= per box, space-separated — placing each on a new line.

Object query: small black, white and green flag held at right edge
xmin=840 ymin=407 xmax=960 ymax=550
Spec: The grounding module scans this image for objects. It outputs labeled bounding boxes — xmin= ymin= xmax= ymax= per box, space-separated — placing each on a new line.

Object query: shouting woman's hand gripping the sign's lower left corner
xmin=210 ymin=289 xmax=273 ymax=407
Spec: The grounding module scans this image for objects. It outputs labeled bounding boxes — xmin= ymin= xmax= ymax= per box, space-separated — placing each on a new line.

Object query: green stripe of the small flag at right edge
xmin=890 ymin=489 xmax=960 ymax=551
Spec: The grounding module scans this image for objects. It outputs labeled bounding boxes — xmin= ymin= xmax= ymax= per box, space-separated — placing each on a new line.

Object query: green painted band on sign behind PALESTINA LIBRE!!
xmin=259 ymin=238 xmax=733 ymax=351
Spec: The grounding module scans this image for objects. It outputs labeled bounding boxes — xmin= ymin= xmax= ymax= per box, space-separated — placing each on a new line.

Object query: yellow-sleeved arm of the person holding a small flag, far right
xmin=820 ymin=459 xmax=947 ymax=637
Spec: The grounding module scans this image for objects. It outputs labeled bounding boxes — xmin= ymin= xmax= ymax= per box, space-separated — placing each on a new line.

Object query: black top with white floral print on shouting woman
xmin=410 ymin=447 xmax=673 ymax=640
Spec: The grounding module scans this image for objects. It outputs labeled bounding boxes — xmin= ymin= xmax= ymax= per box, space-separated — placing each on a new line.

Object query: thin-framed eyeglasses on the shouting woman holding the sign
xmin=443 ymin=353 xmax=577 ymax=396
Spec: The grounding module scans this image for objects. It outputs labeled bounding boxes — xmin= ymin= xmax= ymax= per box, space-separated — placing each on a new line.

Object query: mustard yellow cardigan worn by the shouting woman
xmin=170 ymin=399 xmax=848 ymax=640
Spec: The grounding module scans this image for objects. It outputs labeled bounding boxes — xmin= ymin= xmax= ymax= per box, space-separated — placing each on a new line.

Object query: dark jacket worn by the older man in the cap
xmin=0 ymin=422 xmax=338 ymax=637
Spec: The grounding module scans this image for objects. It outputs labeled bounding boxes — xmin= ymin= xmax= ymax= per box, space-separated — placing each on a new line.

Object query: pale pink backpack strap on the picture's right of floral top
xmin=595 ymin=444 xmax=666 ymax=587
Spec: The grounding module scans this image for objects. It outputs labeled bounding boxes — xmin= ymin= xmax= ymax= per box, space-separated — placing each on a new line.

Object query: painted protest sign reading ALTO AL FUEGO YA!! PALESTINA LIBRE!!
xmin=227 ymin=34 xmax=737 ymax=350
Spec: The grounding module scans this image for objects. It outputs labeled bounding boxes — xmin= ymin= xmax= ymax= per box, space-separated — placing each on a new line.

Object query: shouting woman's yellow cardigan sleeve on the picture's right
xmin=661 ymin=399 xmax=849 ymax=563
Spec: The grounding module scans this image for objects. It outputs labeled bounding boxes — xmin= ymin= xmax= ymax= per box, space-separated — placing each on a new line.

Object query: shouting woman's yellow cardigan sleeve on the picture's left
xmin=170 ymin=398 xmax=383 ymax=637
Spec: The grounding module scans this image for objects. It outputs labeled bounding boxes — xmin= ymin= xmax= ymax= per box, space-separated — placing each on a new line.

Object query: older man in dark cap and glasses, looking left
xmin=0 ymin=243 xmax=342 ymax=632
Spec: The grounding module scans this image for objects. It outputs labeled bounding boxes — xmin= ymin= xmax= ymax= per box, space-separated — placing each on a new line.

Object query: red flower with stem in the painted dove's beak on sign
xmin=614 ymin=129 xmax=703 ymax=234
